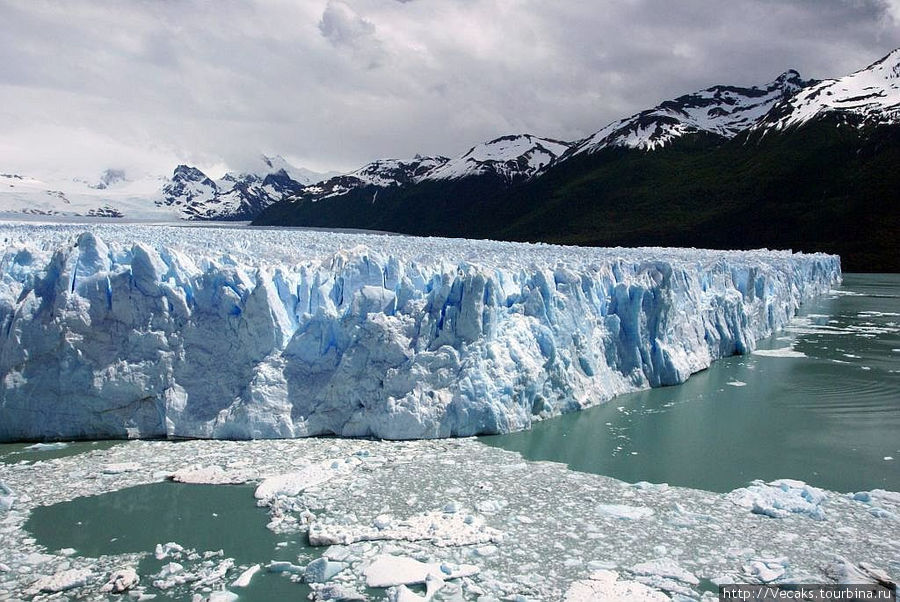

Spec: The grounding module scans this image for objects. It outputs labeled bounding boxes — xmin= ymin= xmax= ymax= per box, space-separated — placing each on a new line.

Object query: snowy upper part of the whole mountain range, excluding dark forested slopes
xmin=8 ymin=49 xmax=900 ymax=223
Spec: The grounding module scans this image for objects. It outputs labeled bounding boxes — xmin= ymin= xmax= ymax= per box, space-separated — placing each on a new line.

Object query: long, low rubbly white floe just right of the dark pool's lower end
xmin=309 ymin=511 xmax=502 ymax=547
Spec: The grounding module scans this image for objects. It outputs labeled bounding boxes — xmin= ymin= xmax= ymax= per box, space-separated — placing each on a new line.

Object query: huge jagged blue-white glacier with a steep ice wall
xmin=0 ymin=223 xmax=841 ymax=441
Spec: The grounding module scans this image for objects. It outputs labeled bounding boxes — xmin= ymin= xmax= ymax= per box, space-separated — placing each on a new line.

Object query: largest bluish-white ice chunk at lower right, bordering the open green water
xmin=726 ymin=479 xmax=827 ymax=520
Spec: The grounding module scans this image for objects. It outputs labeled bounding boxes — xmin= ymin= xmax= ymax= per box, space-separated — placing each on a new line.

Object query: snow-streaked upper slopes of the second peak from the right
xmin=571 ymin=70 xmax=814 ymax=155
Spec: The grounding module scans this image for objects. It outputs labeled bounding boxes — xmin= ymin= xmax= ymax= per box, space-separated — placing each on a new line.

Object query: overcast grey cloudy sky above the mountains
xmin=0 ymin=0 xmax=900 ymax=176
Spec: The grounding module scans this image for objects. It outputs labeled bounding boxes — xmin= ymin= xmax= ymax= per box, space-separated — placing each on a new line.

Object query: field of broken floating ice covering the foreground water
xmin=0 ymin=438 xmax=900 ymax=602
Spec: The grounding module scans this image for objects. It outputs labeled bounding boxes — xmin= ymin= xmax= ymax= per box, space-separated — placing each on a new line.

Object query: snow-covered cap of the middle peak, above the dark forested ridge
xmin=422 ymin=134 xmax=572 ymax=182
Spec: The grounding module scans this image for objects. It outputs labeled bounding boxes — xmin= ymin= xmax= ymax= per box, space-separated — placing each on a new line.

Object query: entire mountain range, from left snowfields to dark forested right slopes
xmin=0 ymin=49 xmax=900 ymax=271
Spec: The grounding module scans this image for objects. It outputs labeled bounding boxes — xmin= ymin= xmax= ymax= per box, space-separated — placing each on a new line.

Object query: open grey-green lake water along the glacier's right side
xmin=481 ymin=274 xmax=900 ymax=492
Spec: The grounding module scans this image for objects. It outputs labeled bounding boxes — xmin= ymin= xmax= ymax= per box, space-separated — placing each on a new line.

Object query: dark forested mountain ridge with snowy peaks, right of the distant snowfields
xmin=254 ymin=50 xmax=900 ymax=271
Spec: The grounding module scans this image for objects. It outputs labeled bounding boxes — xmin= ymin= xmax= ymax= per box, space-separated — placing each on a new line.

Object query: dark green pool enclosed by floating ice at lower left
xmin=25 ymin=482 xmax=321 ymax=602
